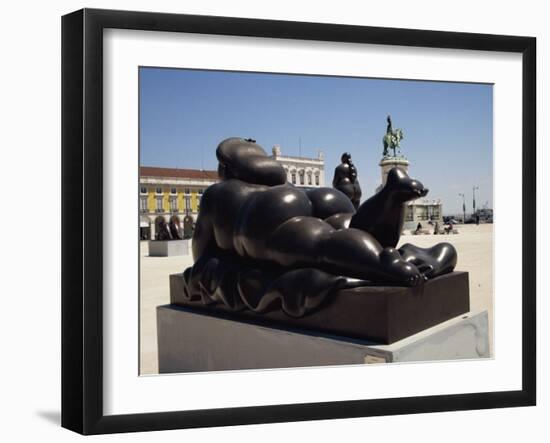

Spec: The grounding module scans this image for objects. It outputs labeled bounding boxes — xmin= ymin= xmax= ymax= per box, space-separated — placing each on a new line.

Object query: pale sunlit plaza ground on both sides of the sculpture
xmin=140 ymin=224 xmax=493 ymax=374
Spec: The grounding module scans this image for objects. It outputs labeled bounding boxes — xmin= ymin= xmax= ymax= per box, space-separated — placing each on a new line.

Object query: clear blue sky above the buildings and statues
xmin=140 ymin=68 xmax=493 ymax=214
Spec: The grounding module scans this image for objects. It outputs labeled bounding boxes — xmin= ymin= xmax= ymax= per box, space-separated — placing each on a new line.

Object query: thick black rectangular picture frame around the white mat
xmin=62 ymin=9 xmax=536 ymax=434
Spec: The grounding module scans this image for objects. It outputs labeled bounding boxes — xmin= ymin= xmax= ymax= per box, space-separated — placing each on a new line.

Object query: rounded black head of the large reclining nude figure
xmin=216 ymin=137 xmax=287 ymax=186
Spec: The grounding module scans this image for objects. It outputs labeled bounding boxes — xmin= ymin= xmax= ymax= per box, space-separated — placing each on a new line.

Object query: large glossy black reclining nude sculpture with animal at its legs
xmin=178 ymin=138 xmax=457 ymax=317
